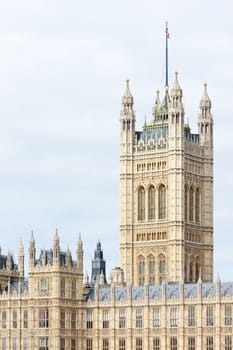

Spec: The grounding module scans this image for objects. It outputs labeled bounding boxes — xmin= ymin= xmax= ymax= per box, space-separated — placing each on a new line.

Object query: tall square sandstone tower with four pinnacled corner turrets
xmin=120 ymin=73 xmax=213 ymax=285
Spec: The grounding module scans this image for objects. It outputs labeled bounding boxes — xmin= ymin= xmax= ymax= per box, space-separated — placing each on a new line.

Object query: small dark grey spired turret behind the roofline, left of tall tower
xmin=91 ymin=241 xmax=107 ymax=284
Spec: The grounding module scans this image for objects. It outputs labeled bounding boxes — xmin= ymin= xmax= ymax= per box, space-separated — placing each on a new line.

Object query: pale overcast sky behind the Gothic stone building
xmin=0 ymin=0 xmax=233 ymax=281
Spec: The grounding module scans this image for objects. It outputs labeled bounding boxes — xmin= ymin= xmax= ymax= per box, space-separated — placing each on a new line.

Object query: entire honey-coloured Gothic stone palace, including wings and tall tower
xmin=0 ymin=56 xmax=233 ymax=350
